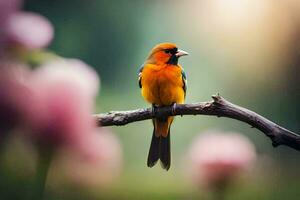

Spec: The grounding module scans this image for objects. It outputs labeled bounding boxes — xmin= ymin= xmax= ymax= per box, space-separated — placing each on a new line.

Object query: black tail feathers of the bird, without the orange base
xmin=147 ymin=130 xmax=171 ymax=170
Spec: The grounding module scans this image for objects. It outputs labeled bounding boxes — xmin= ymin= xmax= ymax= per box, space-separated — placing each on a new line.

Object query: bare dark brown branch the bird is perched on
xmin=94 ymin=95 xmax=300 ymax=150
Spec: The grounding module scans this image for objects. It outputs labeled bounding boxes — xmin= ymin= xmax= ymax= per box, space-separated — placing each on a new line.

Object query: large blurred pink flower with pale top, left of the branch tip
xmin=28 ymin=59 xmax=99 ymax=147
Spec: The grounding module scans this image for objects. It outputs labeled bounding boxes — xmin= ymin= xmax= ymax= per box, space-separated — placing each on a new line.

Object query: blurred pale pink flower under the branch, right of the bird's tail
xmin=188 ymin=132 xmax=256 ymax=189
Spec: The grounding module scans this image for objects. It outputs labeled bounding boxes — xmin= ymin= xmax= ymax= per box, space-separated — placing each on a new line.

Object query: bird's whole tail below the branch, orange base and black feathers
xmin=147 ymin=117 xmax=173 ymax=170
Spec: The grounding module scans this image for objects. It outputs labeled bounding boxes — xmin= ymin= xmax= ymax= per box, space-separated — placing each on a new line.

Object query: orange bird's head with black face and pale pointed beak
xmin=147 ymin=43 xmax=188 ymax=65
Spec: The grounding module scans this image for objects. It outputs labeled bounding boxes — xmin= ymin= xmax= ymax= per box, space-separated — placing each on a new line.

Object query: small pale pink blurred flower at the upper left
xmin=4 ymin=12 xmax=54 ymax=49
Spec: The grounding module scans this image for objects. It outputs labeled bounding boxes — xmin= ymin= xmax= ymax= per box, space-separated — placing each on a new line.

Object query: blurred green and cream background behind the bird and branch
xmin=1 ymin=0 xmax=300 ymax=199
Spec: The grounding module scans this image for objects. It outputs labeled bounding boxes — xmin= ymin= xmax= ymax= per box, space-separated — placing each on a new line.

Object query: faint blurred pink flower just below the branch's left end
xmin=54 ymin=128 xmax=122 ymax=188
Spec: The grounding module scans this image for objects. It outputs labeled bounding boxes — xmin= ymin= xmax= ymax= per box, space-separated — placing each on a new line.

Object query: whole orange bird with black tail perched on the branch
xmin=138 ymin=42 xmax=188 ymax=171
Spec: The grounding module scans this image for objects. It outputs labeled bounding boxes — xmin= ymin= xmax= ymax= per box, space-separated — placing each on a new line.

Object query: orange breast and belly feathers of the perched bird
xmin=140 ymin=64 xmax=185 ymax=105
